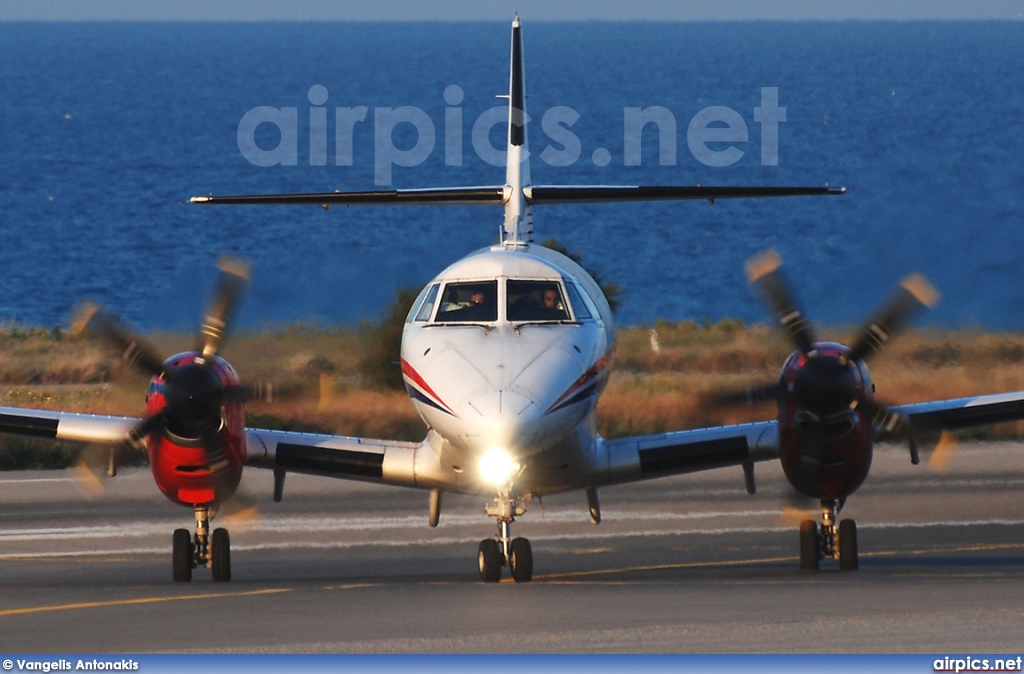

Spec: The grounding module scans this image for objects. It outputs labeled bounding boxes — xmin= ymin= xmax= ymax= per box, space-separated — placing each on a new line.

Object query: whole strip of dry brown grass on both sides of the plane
xmin=0 ymin=321 xmax=1024 ymax=467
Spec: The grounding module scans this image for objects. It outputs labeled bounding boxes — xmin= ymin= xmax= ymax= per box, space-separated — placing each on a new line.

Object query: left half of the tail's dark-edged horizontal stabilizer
xmin=188 ymin=186 xmax=505 ymax=206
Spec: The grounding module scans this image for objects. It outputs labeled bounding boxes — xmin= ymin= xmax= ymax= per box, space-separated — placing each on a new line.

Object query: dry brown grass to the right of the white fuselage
xmin=600 ymin=321 xmax=1024 ymax=437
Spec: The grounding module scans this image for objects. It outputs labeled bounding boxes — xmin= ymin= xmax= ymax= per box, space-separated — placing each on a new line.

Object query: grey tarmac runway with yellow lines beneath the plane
xmin=0 ymin=444 xmax=1024 ymax=655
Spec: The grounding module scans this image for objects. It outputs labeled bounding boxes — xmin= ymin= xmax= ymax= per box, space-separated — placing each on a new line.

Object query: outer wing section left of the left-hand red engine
xmin=0 ymin=407 xmax=142 ymax=445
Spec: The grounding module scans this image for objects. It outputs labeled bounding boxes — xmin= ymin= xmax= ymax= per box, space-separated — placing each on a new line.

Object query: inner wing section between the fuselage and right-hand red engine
xmin=602 ymin=421 xmax=778 ymax=494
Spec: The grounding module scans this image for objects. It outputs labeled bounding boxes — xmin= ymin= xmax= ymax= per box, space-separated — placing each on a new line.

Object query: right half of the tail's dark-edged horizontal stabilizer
xmin=525 ymin=185 xmax=846 ymax=204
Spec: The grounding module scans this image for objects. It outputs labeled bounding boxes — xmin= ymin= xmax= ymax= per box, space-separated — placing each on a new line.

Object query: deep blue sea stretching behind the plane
xmin=0 ymin=22 xmax=1024 ymax=330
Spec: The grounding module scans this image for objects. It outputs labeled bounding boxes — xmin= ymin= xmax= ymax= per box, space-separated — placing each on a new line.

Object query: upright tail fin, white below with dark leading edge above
xmin=503 ymin=15 xmax=534 ymax=246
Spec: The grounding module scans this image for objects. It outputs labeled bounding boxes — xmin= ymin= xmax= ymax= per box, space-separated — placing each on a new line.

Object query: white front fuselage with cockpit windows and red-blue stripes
xmin=401 ymin=244 xmax=614 ymax=494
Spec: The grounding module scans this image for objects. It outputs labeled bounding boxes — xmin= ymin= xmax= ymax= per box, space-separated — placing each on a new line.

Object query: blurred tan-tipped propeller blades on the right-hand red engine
xmin=718 ymin=250 xmax=939 ymax=464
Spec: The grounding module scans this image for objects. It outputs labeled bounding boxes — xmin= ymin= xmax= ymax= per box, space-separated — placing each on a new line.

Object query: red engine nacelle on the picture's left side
xmin=145 ymin=351 xmax=246 ymax=506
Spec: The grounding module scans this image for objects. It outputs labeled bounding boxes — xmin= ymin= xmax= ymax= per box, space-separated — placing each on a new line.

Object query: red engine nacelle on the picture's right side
xmin=778 ymin=342 xmax=874 ymax=500
